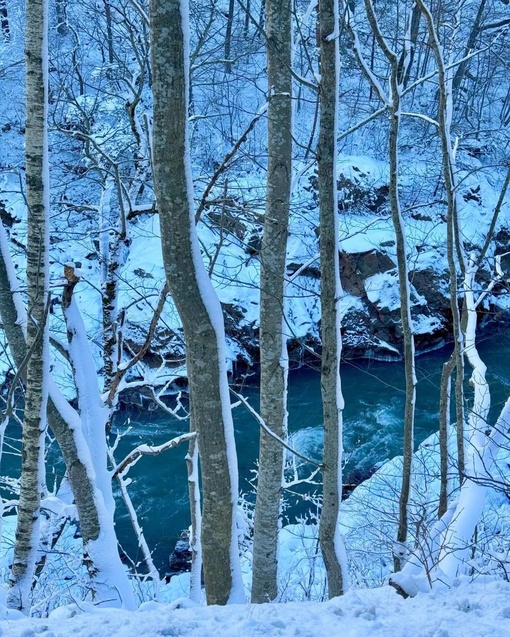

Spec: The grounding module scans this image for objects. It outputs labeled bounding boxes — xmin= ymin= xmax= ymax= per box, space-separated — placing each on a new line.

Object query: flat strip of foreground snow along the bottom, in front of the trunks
xmin=0 ymin=579 xmax=510 ymax=637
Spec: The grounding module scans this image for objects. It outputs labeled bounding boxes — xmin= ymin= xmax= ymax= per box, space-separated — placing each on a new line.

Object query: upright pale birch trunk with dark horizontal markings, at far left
xmin=8 ymin=0 xmax=49 ymax=612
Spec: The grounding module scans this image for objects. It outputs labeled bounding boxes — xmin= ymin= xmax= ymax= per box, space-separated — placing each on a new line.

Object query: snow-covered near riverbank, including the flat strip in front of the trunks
xmin=0 ymin=422 xmax=510 ymax=637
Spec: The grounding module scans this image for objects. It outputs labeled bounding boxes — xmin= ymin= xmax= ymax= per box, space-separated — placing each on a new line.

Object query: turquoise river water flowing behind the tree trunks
xmin=109 ymin=333 xmax=510 ymax=571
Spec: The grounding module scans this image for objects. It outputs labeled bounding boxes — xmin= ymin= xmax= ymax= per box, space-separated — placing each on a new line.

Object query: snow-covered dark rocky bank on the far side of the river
xmin=0 ymin=137 xmax=510 ymax=396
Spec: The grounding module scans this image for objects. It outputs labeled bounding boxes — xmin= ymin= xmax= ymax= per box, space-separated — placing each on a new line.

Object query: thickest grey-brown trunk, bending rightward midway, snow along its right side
xmin=150 ymin=0 xmax=244 ymax=604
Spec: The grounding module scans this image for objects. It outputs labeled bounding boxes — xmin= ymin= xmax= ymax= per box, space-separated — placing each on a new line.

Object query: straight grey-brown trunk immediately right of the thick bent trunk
xmin=251 ymin=0 xmax=292 ymax=603
